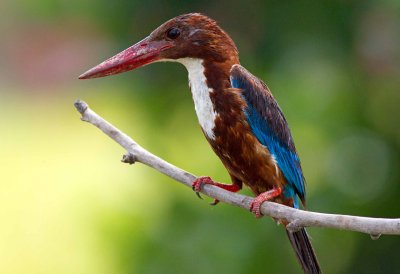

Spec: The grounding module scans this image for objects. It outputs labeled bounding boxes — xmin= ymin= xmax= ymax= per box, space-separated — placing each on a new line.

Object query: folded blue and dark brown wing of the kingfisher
xmin=230 ymin=65 xmax=305 ymax=206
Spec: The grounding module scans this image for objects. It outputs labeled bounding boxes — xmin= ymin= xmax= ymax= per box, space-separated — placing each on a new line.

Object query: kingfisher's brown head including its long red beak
xmin=79 ymin=13 xmax=238 ymax=79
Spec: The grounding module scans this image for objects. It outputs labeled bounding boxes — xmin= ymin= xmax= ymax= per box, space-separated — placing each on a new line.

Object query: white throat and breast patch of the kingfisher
xmin=176 ymin=58 xmax=217 ymax=139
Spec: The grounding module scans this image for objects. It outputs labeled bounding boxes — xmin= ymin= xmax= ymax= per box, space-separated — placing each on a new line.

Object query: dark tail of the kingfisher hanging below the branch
xmin=286 ymin=228 xmax=322 ymax=274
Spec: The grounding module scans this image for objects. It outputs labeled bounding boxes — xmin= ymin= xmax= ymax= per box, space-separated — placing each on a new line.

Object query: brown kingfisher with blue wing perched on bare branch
xmin=79 ymin=13 xmax=321 ymax=274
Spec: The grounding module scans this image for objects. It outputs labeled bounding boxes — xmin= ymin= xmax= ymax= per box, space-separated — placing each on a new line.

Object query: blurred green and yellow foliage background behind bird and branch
xmin=0 ymin=0 xmax=400 ymax=274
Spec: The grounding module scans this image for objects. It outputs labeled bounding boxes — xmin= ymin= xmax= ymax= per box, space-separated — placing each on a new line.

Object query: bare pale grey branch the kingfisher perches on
xmin=74 ymin=100 xmax=400 ymax=239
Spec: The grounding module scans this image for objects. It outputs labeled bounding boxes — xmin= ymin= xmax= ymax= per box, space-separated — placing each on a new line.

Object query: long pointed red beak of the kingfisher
xmin=79 ymin=37 xmax=173 ymax=79
